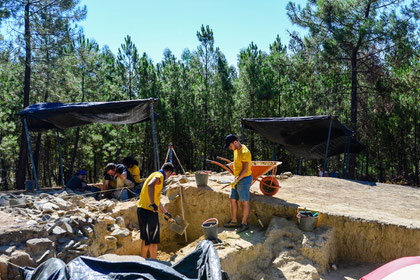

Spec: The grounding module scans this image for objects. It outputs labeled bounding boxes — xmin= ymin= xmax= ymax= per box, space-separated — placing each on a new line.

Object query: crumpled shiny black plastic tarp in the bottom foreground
xmin=21 ymin=240 xmax=222 ymax=280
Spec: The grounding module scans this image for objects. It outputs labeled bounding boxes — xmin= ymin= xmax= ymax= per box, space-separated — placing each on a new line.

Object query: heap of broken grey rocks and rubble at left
xmin=0 ymin=191 xmax=140 ymax=279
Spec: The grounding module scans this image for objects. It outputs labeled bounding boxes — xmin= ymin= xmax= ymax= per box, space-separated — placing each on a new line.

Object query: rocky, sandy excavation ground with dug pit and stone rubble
xmin=0 ymin=172 xmax=420 ymax=279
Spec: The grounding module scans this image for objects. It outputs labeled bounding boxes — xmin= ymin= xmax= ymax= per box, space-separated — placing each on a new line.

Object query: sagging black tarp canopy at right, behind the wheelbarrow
xmin=242 ymin=116 xmax=364 ymax=159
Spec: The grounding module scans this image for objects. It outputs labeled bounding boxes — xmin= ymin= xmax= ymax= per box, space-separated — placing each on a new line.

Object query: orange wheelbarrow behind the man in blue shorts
xmin=207 ymin=157 xmax=282 ymax=196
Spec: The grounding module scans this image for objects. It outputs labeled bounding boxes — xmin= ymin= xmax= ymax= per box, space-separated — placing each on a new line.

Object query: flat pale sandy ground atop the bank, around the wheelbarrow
xmin=209 ymin=173 xmax=420 ymax=228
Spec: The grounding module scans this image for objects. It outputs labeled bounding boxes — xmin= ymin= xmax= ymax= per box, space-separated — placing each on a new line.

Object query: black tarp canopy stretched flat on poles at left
xmin=18 ymin=98 xmax=158 ymax=131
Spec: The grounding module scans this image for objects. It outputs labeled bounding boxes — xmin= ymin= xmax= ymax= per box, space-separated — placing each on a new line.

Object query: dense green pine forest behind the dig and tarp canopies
xmin=0 ymin=0 xmax=420 ymax=190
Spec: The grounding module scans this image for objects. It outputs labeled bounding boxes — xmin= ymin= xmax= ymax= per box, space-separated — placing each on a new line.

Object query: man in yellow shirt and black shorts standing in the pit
xmin=137 ymin=162 xmax=174 ymax=259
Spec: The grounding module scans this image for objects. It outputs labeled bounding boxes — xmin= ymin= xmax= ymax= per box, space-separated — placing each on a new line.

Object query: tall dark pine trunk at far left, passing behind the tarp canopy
xmin=16 ymin=0 xmax=31 ymax=189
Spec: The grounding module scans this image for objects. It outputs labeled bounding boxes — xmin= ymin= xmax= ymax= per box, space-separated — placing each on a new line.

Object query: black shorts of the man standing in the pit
xmin=137 ymin=208 xmax=160 ymax=245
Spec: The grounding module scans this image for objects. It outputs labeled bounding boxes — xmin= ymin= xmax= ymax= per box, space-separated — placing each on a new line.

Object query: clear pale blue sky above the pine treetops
xmin=78 ymin=0 xmax=306 ymax=66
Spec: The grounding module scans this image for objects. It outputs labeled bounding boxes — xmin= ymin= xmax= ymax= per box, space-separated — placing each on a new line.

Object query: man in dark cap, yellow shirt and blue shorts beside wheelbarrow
xmin=223 ymin=134 xmax=252 ymax=233
